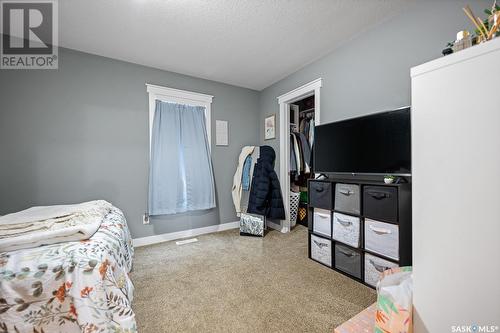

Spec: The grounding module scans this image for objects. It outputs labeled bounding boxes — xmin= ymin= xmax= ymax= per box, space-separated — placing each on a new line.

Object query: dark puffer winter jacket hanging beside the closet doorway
xmin=247 ymin=146 xmax=285 ymax=220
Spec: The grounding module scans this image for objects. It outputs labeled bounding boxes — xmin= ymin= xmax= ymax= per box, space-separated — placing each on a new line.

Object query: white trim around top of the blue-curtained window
xmin=146 ymin=83 xmax=214 ymax=152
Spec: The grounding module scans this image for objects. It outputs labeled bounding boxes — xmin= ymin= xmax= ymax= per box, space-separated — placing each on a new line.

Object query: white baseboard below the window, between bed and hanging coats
xmin=132 ymin=221 xmax=240 ymax=247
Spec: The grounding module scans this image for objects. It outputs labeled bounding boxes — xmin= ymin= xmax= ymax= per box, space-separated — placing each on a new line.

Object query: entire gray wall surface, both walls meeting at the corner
xmin=0 ymin=0 xmax=491 ymax=237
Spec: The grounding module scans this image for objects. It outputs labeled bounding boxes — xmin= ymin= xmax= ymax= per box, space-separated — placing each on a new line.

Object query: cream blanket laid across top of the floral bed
xmin=0 ymin=200 xmax=113 ymax=252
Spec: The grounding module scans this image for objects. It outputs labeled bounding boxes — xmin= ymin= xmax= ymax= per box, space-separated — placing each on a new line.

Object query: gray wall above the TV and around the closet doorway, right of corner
xmin=260 ymin=0 xmax=492 ymax=170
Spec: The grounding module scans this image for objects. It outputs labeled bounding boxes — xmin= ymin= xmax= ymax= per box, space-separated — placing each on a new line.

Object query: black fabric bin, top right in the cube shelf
xmin=363 ymin=186 xmax=398 ymax=222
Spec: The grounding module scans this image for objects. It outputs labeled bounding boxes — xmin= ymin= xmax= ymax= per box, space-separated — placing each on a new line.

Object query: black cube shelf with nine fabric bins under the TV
xmin=308 ymin=177 xmax=412 ymax=288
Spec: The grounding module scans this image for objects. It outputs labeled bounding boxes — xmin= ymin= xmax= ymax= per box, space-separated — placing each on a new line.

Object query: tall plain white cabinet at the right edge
xmin=411 ymin=38 xmax=500 ymax=333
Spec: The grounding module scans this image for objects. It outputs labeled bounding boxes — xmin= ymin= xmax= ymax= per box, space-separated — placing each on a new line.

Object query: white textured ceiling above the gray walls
xmin=59 ymin=0 xmax=410 ymax=90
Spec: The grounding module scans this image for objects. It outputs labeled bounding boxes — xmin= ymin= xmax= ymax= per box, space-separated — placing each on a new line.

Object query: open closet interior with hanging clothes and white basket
xmin=288 ymin=95 xmax=315 ymax=227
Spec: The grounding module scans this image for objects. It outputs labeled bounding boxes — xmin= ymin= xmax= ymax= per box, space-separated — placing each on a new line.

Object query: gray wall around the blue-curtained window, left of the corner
xmin=0 ymin=49 xmax=259 ymax=238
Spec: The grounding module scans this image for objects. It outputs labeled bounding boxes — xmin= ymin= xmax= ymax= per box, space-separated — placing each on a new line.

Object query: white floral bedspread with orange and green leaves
xmin=0 ymin=208 xmax=137 ymax=333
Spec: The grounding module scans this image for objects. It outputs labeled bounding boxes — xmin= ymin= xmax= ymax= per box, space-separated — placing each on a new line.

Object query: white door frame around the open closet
xmin=277 ymin=78 xmax=323 ymax=233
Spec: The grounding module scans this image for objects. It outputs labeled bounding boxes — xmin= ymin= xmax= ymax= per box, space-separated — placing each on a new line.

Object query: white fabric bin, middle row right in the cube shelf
xmin=365 ymin=219 xmax=399 ymax=260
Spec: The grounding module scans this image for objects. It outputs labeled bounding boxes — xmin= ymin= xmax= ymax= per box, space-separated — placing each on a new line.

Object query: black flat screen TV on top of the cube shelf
xmin=314 ymin=107 xmax=411 ymax=176
